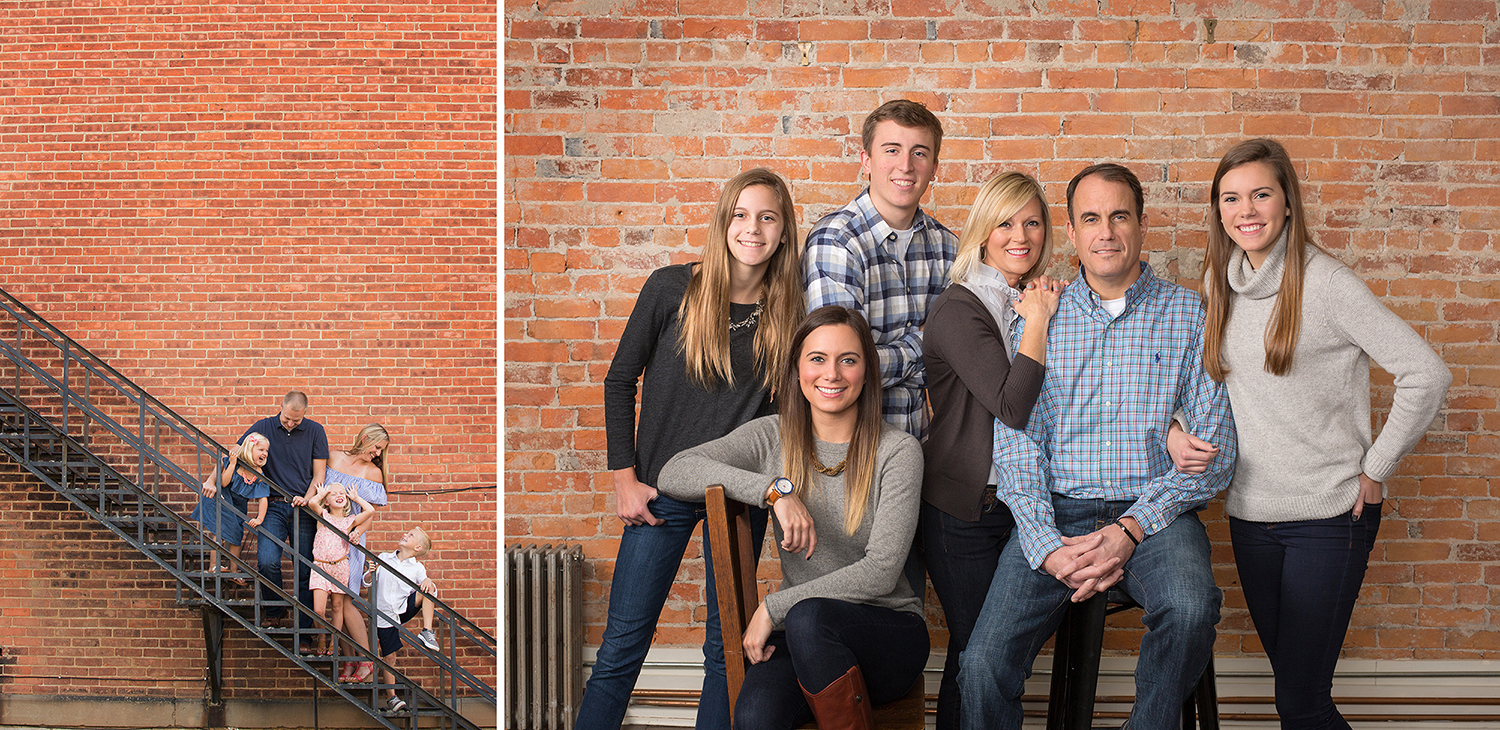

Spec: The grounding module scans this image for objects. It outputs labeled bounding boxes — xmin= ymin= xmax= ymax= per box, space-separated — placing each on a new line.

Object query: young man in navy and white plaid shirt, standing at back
xmin=804 ymin=99 xmax=959 ymax=438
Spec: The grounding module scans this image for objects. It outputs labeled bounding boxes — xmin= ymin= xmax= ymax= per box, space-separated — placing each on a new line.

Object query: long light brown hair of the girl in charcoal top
xmin=677 ymin=168 xmax=807 ymax=390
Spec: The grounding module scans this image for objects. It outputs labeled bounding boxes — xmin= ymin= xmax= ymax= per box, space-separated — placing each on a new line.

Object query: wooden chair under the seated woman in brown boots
xmin=705 ymin=484 xmax=927 ymax=730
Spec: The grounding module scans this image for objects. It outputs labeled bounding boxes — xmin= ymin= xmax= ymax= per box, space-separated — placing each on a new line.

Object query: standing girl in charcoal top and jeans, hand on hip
xmin=578 ymin=168 xmax=806 ymax=729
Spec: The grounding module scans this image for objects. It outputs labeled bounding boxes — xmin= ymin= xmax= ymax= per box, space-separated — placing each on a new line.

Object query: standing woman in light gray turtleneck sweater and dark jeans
xmin=1193 ymin=139 xmax=1452 ymax=729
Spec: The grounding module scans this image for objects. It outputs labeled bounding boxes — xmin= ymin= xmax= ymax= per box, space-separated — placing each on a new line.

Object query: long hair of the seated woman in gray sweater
xmin=779 ymin=304 xmax=881 ymax=535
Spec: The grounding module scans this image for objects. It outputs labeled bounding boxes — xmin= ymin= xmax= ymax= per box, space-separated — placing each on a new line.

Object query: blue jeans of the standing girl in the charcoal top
xmin=575 ymin=495 xmax=767 ymax=730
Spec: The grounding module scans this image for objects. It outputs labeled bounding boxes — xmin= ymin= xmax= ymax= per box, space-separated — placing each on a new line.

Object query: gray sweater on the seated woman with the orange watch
xmin=657 ymin=415 xmax=923 ymax=628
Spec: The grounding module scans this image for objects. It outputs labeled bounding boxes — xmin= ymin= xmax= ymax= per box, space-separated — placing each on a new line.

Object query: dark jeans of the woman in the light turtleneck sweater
xmin=1229 ymin=504 xmax=1380 ymax=730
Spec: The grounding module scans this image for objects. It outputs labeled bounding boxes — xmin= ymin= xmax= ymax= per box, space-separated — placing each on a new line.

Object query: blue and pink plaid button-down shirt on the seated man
xmin=995 ymin=264 xmax=1236 ymax=568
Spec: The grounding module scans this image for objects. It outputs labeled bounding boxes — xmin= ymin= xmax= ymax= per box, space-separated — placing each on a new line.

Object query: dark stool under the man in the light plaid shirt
xmin=1047 ymin=589 xmax=1218 ymax=730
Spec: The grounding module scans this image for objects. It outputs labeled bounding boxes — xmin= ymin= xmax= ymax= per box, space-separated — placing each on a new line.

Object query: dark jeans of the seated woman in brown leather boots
xmin=735 ymin=598 xmax=932 ymax=730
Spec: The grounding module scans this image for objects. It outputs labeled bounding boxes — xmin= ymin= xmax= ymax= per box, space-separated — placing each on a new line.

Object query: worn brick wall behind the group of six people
xmin=503 ymin=0 xmax=1500 ymax=658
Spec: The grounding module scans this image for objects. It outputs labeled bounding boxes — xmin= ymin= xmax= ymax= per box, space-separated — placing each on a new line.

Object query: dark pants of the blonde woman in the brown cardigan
xmin=918 ymin=492 xmax=1016 ymax=730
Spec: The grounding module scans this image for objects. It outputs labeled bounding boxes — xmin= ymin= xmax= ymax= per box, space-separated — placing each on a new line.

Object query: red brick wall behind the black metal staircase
xmin=0 ymin=0 xmax=498 ymax=699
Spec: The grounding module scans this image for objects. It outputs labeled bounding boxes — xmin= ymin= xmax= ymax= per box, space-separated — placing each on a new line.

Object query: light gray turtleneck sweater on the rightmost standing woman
xmin=1224 ymin=235 xmax=1452 ymax=522
